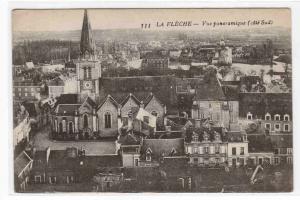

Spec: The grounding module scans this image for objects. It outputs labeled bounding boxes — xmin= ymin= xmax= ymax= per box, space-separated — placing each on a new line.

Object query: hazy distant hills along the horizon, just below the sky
xmin=13 ymin=27 xmax=291 ymax=48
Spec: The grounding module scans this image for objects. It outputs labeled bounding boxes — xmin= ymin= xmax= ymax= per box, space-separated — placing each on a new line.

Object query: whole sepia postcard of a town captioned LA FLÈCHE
xmin=10 ymin=7 xmax=294 ymax=193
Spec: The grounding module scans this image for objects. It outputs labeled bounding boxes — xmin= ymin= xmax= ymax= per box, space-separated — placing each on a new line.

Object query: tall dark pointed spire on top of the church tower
xmin=80 ymin=9 xmax=96 ymax=59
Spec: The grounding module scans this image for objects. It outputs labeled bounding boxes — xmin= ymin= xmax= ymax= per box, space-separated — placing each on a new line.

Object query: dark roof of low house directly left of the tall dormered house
xmin=141 ymin=138 xmax=184 ymax=159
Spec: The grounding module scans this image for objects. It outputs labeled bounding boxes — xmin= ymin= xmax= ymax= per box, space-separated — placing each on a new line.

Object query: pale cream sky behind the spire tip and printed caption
xmin=12 ymin=8 xmax=291 ymax=32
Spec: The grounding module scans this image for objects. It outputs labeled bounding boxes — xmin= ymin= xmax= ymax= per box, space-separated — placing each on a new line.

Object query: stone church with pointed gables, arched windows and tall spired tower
xmin=51 ymin=10 xmax=166 ymax=140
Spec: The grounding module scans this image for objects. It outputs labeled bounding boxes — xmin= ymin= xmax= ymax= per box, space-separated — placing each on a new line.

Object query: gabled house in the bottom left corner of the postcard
xmin=14 ymin=151 xmax=33 ymax=192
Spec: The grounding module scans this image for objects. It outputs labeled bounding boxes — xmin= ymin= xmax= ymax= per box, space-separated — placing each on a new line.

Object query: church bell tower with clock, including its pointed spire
xmin=76 ymin=9 xmax=101 ymax=101
